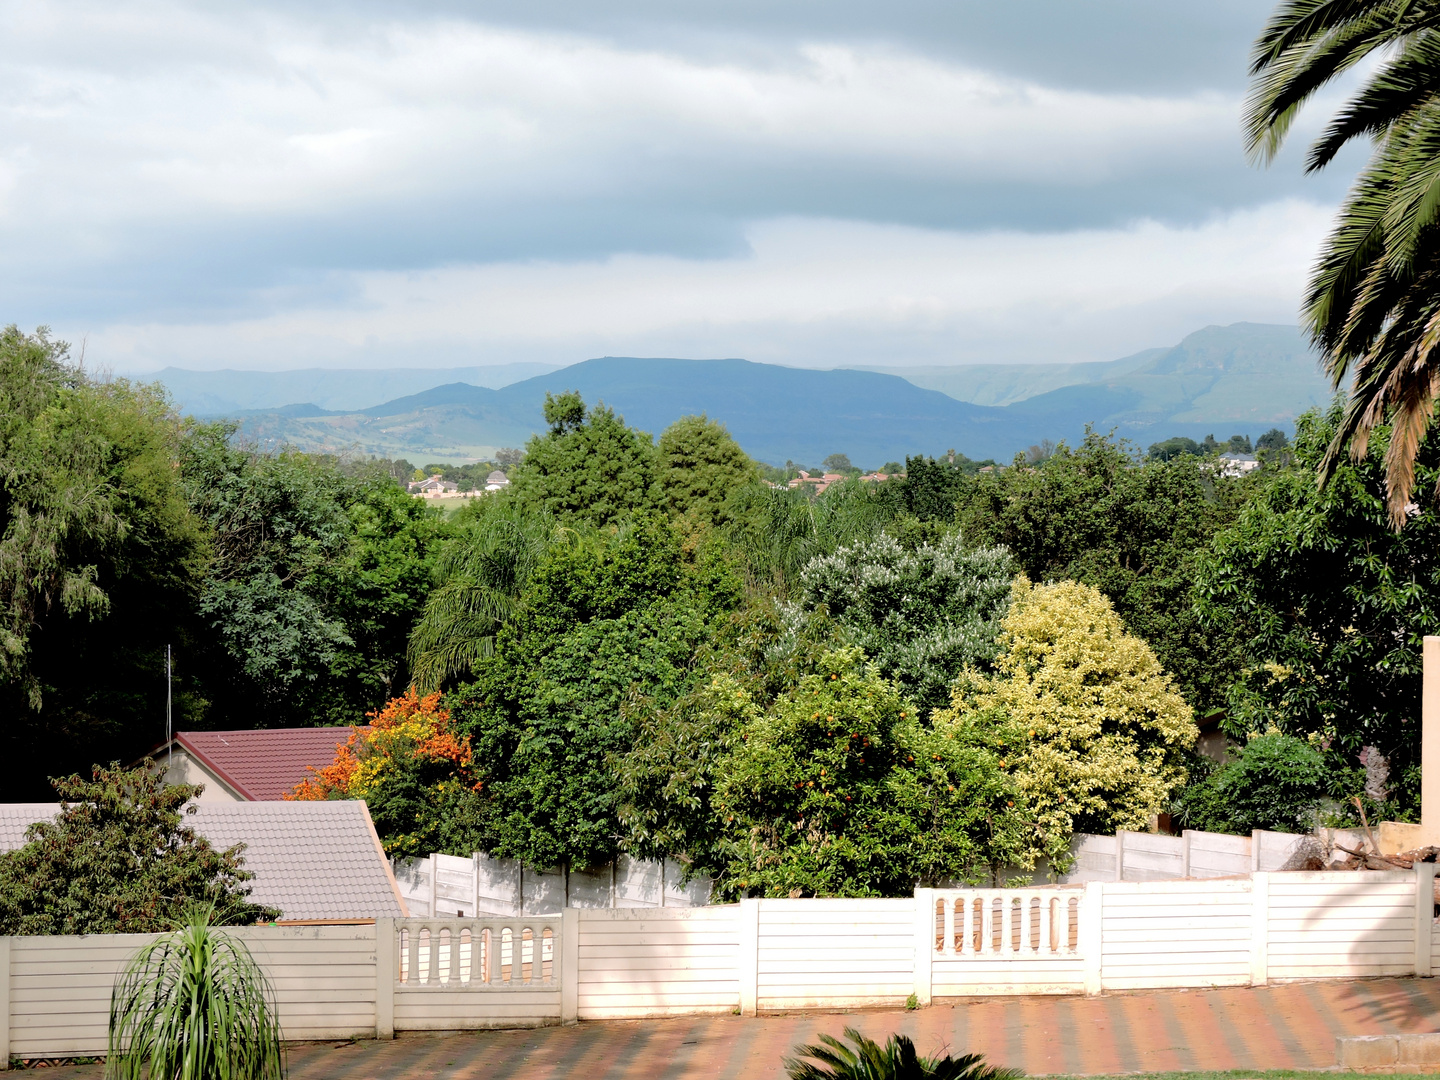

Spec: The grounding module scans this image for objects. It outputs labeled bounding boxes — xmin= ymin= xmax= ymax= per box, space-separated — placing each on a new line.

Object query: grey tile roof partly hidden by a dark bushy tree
xmin=0 ymin=801 xmax=405 ymax=919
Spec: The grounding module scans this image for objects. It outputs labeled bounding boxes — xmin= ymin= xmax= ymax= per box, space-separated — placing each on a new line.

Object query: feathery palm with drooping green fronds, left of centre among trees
xmin=409 ymin=504 xmax=569 ymax=693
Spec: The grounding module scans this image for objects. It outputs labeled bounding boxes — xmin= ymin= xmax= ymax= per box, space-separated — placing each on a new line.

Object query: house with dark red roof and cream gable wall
xmin=150 ymin=727 xmax=354 ymax=802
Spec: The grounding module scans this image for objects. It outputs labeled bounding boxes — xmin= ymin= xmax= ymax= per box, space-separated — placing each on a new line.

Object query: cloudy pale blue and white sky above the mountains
xmin=0 ymin=0 xmax=1359 ymax=373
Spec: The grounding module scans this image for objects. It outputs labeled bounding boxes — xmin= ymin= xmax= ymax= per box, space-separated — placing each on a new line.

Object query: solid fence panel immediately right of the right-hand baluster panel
xmin=1100 ymin=881 xmax=1254 ymax=989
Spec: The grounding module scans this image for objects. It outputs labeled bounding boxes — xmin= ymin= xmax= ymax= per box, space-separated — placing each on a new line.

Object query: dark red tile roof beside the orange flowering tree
xmin=176 ymin=727 xmax=354 ymax=802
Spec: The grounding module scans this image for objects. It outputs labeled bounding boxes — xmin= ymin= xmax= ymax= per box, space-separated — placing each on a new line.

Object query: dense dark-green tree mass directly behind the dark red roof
xmin=181 ymin=423 xmax=451 ymax=727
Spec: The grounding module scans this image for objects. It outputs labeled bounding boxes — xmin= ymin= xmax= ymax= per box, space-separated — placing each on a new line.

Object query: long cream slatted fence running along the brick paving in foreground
xmin=0 ymin=863 xmax=1440 ymax=1061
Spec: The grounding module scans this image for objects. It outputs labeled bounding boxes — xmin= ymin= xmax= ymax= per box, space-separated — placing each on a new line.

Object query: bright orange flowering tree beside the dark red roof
xmin=287 ymin=687 xmax=484 ymax=857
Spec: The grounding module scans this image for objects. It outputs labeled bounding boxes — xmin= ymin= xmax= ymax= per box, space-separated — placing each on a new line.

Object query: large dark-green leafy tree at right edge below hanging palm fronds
xmin=1195 ymin=406 xmax=1440 ymax=814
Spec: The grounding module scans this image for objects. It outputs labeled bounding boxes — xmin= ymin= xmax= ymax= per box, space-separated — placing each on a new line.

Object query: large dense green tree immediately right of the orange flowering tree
xmin=452 ymin=513 xmax=740 ymax=867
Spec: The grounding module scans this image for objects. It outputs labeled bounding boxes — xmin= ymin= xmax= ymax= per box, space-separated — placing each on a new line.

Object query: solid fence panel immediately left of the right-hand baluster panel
xmin=756 ymin=897 xmax=914 ymax=1011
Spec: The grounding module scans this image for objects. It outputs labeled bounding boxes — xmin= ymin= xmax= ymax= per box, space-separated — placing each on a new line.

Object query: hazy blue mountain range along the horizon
xmin=160 ymin=323 xmax=1331 ymax=467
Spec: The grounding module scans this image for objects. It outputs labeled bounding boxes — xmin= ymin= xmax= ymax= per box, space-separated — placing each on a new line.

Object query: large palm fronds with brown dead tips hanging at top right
xmin=1246 ymin=0 xmax=1440 ymax=528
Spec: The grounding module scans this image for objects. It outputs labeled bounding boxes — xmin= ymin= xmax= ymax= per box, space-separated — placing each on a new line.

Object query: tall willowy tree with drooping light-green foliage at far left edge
xmin=0 ymin=325 xmax=207 ymax=798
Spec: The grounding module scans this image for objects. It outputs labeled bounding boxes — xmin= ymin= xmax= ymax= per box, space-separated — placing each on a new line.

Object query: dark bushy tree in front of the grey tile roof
xmin=0 ymin=765 xmax=279 ymax=935
